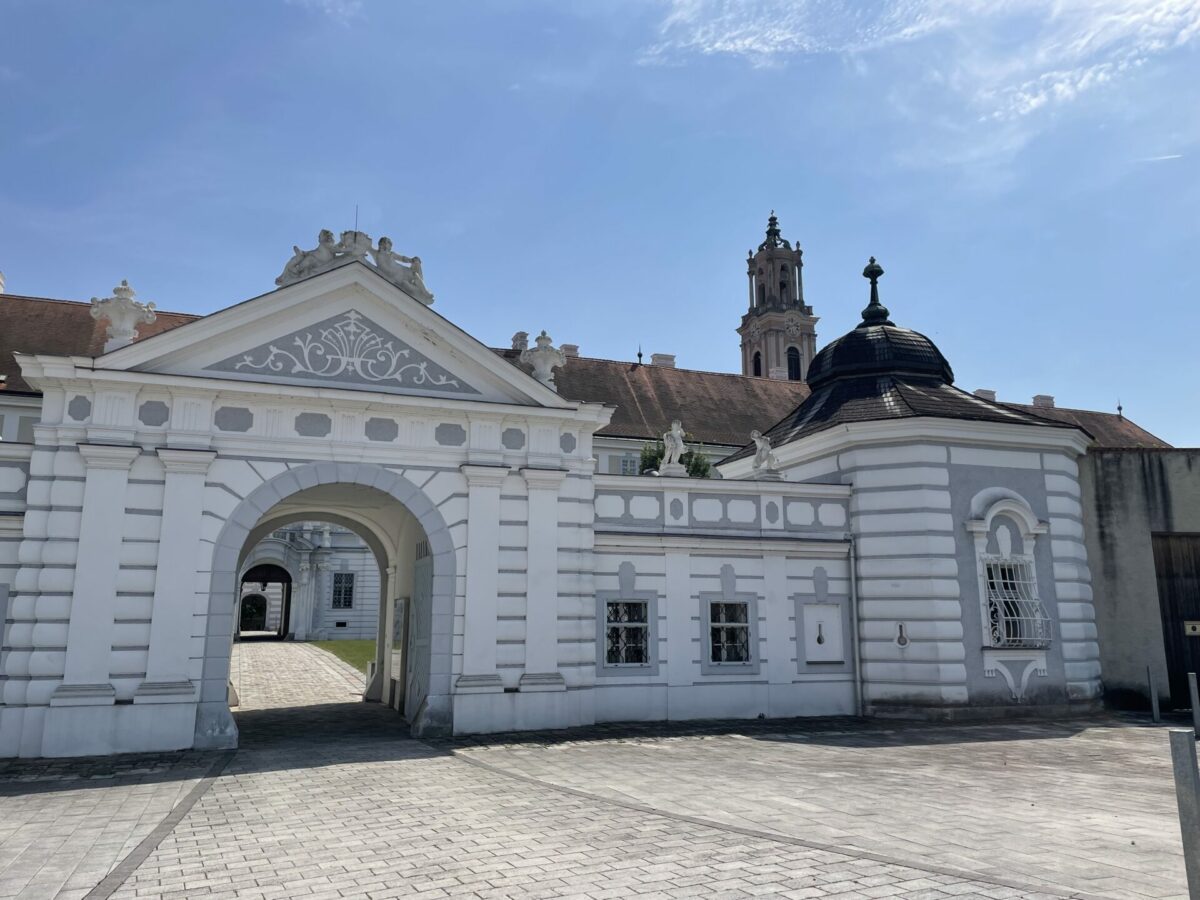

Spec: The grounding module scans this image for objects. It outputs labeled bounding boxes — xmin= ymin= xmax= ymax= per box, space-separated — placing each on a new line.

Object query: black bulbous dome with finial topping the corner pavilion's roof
xmin=806 ymin=257 xmax=954 ymax=391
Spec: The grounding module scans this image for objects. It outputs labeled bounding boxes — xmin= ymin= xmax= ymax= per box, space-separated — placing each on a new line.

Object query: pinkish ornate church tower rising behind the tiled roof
xmin=738 ymin=210 xmax=817 ymax=382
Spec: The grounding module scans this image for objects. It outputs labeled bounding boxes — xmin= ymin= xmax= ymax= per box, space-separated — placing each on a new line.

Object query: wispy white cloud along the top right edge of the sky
xmin=642 ymin=0 xmax=1200 ymax=120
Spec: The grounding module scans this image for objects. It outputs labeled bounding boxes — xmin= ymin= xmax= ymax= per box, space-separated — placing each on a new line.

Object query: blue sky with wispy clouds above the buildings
xmin=0 ymin=0 xmax=1200 ymax=445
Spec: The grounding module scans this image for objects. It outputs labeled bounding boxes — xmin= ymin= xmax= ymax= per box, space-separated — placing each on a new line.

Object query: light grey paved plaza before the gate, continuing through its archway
xmin=0 ymin=643 xmax=1186 ymax=899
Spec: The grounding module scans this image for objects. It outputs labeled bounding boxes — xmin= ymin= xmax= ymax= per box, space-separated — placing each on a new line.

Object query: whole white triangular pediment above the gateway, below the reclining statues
xmin=96 ymin=263 xmax=574 ymax=408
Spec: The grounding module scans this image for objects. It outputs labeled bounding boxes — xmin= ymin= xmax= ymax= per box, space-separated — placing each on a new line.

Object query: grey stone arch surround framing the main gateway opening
xmin=194 ymin=462 xmax=456 ymax=749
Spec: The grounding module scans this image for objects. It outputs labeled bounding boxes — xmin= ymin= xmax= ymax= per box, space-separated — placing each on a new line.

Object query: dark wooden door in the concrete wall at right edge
xmin=1153 ymin=534 xmax=1200 ymax=709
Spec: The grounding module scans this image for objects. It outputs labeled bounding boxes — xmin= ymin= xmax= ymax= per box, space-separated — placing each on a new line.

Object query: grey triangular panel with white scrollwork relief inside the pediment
xmin=205 ymin=310 xmax=479 ymax=394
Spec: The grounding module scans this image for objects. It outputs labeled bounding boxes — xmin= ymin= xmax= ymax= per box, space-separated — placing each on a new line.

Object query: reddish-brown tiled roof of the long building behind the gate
xmin=0 ymin=294 xmax=1170 ymax=448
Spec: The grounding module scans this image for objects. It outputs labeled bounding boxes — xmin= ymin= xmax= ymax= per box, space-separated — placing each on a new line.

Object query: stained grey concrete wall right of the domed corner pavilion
xmin=1080 ymin=449 xmax=1200 ymax=707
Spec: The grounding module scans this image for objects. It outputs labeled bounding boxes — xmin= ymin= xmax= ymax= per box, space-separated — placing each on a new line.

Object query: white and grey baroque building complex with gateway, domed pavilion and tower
xmin=0 ymin=216 xmax=1162 ymax=757
